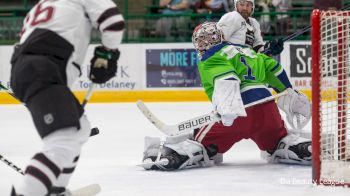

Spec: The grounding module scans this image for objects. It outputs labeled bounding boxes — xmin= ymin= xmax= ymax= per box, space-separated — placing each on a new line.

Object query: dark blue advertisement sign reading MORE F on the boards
xmin=146 ymin=49 xmax=201 ymax=88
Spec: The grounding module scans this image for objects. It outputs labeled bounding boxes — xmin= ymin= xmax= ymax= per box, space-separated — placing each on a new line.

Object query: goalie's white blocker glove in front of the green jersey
xmin=212 ymin=78 xmax=247 ymax=126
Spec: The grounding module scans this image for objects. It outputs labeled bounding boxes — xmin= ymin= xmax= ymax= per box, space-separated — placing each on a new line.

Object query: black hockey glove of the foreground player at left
xmin=89 ymin=46 xmax=120 ymax=84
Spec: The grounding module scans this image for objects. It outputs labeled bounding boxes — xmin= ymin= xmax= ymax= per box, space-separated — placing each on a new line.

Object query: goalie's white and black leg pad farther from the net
xmin=141 ymin=137 xmax=213 ymax=170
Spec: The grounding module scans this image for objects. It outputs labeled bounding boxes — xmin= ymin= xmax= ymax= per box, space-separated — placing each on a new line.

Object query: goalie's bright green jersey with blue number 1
xmin=198 ymin=42 xmax=292 ymax=104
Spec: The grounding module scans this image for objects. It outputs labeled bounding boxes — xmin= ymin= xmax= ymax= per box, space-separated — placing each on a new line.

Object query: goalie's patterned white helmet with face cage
xmin=192 ymin=22 xmax=223 ymax=55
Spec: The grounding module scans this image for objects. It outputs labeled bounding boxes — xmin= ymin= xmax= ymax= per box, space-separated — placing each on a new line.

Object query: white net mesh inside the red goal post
xmin=320 ymin=11 xmax=350 ymax=183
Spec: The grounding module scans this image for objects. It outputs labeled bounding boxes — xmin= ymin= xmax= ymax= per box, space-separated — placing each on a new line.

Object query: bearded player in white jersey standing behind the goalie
xmin=217 ymin=0 xmax=283 ymax=55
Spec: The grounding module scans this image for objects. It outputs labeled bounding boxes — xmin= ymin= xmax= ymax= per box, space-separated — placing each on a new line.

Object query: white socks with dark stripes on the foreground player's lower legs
xmin=16 ymin=115 xmax=91 ymax=196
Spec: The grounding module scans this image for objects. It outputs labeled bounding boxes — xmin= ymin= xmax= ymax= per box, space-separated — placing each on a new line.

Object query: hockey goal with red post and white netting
xmin=311 ymin=10 xmax=350 ymax=186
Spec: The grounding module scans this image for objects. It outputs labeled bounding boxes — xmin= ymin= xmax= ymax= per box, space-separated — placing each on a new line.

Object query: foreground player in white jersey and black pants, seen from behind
xmin=11 ymin=0 xmax=125 ymax=196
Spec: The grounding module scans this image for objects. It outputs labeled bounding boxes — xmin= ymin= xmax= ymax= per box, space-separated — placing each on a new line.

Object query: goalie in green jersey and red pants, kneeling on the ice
xmin=141 ymin=22 xmax=311 ymax=170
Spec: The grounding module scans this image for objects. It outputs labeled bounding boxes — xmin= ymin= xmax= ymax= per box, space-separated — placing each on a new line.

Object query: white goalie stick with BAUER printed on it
xmin=136 ymin=91 xmax=287 ymax=136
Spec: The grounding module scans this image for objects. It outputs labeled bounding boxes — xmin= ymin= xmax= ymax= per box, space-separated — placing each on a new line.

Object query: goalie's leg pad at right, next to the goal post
xmin=267 ymin=134 xmax=311 ymax=165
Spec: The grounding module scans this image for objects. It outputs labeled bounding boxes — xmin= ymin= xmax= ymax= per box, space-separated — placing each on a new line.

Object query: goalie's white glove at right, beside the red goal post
xmin=277 ymin=88 xmax=311 ymax=130
